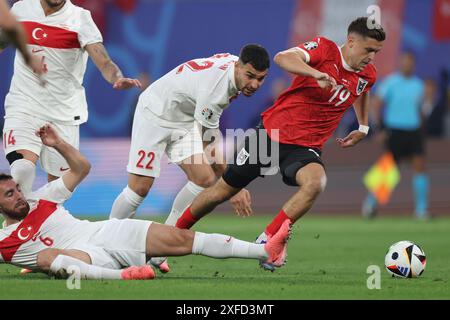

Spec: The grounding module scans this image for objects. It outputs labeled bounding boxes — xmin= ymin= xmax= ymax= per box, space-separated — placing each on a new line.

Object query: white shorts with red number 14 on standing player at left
xmin=3 ymin=114 xmax=80 ymax=177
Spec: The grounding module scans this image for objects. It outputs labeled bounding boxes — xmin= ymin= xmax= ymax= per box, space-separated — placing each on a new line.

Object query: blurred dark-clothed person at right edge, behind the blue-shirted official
xmin=422 ymin=70 xmax=449 ymax=138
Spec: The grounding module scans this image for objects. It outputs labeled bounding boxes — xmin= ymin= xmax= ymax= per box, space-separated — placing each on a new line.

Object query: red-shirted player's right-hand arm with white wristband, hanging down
xmin=336 ymin=92 xmax=370 ymax=148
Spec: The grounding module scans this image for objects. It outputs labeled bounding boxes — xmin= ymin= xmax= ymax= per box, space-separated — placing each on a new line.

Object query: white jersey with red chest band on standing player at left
xmin=5 ymin=0 xmax=103 ymax=125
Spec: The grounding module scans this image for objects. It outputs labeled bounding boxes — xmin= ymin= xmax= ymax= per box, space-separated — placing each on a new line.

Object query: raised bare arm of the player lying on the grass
xmin=36 ymin=124 xmax=91 ymax=192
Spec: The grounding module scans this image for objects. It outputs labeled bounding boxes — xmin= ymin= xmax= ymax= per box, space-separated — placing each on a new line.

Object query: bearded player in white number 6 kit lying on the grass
xmin=0 ymin=125 xmax=290 ymax=280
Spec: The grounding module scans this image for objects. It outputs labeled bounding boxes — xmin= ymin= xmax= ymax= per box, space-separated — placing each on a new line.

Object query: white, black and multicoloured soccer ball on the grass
xmin=384 ymin=241 xmax=427 ymax=278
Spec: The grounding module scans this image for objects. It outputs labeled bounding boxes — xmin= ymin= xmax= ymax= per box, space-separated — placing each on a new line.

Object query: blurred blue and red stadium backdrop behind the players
xmin=0 ymin=0 xmax=450 ymax=216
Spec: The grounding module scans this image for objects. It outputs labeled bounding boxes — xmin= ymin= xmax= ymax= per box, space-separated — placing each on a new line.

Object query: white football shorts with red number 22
xmin=127 ymin=105 xmax=203 ymax=178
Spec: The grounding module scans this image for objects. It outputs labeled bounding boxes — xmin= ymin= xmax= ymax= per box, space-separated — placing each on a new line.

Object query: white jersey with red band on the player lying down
xmin=0 ymin=178 xmax=104 ymax=269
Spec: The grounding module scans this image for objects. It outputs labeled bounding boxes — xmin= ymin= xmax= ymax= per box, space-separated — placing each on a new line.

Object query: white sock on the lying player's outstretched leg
xmin=192 ymin=232 xmax=268 ymax=260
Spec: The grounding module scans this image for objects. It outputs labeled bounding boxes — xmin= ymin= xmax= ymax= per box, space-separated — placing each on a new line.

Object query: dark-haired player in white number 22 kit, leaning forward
xmin=110 ymin=44 xmax=270 ymax=272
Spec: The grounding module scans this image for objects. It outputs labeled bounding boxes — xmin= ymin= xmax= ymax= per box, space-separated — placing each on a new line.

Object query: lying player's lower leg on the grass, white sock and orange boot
xmin=37 ymin=248 xmax=155 ymax=280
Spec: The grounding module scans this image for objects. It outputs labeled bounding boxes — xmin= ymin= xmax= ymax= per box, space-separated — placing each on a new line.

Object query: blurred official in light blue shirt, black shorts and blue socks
xmin=362 ymin=52 xmax=432 ymax=219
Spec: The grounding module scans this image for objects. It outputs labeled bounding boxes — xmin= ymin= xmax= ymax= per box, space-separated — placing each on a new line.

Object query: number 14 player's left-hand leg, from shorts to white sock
xmin=3 ymin=115 xmax=42 ymax=193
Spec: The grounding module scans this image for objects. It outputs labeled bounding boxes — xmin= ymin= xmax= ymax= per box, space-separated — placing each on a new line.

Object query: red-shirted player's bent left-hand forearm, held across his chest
xmin=273 ymin=47 xmax=336 ymax=89
